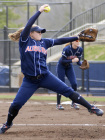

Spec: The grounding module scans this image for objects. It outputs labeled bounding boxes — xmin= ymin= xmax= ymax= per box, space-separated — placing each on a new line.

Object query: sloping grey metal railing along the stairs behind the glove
xmin=52 ymin=2 xmax=105 ymax=38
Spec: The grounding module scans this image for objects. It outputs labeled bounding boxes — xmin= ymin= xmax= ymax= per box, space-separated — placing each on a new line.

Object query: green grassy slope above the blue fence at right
xmin=84 ymin=44 xmax=105 ymax=61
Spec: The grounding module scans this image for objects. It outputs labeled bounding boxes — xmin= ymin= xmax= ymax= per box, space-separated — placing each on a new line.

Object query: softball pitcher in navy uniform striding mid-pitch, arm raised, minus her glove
xmin=0 ymin=4 xmax=103 ymax=134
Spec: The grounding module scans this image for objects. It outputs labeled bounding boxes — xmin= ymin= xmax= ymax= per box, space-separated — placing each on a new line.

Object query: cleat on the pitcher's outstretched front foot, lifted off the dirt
xmin=88 ymin=105 xmax=104 ymax=116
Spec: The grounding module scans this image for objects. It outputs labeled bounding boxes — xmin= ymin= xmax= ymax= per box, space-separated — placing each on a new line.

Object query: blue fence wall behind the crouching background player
xmin=48 ymin=61 xmax=105 ymax=96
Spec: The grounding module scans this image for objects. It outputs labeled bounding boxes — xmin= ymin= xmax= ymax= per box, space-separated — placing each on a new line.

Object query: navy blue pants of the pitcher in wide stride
xmin=11 ymin=72 xmax=74 ymax=110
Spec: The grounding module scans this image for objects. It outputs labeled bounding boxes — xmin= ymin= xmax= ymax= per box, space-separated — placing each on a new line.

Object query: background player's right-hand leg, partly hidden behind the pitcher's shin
xmin=66 ymin=65 xmax=79 ymax=110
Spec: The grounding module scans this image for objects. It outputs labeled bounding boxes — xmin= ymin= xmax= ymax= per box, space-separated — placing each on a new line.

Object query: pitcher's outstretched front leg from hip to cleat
xmin=40 ymin=72 xmax=103 ymax=116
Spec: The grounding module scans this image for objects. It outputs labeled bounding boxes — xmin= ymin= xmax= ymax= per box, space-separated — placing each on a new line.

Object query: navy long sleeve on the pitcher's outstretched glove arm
xmin=54 ymin=37 xmax=78 ymax=45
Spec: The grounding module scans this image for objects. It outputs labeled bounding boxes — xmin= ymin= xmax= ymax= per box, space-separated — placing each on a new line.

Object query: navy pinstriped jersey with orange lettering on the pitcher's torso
xmin=19 ymin=37 xmax=53 ymax=76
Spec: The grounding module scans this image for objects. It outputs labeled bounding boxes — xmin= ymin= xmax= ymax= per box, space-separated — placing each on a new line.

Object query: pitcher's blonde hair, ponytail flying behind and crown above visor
xmin=8 ymin=24 xmax=37 ymax=42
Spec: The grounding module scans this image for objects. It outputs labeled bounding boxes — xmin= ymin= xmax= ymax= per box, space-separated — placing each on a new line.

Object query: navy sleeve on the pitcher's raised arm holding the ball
xmin=20 ymin=11 xmax=41 ymax=42
